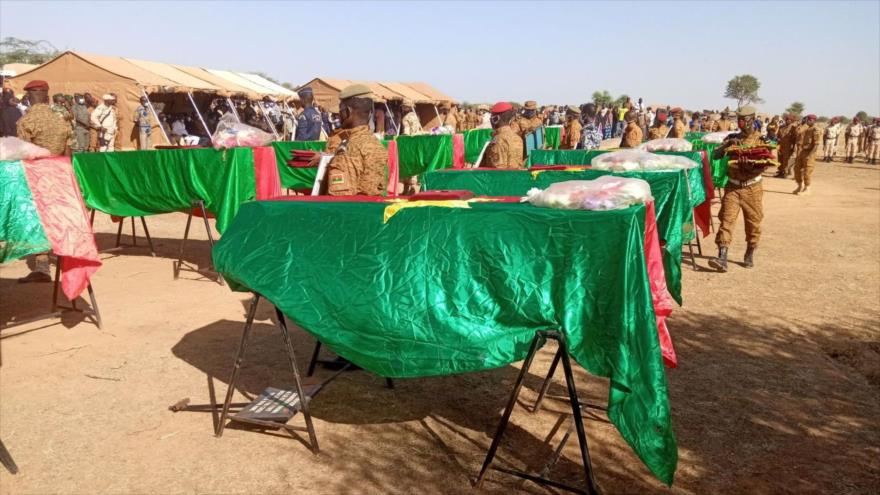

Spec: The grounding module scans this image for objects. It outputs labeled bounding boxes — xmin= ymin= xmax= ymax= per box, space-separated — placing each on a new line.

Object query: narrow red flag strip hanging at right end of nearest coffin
xmin=645 ymin=201 xmax=678 ymax=368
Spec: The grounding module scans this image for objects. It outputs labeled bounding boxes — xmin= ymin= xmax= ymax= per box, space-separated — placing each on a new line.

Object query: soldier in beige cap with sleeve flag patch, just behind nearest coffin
xmin=327 ymin=84 xmax=388 ymax=196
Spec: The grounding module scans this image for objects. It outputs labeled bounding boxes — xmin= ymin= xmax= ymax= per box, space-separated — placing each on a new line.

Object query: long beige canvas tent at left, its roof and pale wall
xmin=8 ymin=51 xmax=296 ymax=149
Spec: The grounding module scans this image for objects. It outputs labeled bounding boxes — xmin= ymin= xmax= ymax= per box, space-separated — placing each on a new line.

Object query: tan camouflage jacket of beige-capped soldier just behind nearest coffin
xmin=327 ymin=125 xmax=388 ymax=196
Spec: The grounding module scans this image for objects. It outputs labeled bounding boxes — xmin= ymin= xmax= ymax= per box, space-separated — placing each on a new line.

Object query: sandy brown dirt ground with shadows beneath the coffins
xmin=0 ymin=156 xmax=880 ymax=494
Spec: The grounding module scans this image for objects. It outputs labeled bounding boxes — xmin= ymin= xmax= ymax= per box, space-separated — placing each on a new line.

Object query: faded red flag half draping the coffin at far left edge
xmin=22 ymin=156 xmax=101 ymax=301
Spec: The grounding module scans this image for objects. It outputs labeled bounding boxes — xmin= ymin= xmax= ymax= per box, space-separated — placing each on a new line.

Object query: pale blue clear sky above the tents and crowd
xmin=0 ymin=0 xmax=880 ymax=116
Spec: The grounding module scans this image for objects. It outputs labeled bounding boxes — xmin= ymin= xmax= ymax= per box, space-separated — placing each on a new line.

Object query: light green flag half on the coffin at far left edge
xmin=0 ymin=161 xmax=52 ymax=263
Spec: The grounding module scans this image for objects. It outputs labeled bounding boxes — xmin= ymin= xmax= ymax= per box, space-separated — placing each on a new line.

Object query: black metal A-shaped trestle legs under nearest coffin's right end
xmin=474 ymin=331 xmax=599 ymax=495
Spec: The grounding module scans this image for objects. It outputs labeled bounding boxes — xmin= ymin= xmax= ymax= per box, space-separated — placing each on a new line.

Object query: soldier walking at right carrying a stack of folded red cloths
xmin=709 ymin=107 xmax=764 ymax=272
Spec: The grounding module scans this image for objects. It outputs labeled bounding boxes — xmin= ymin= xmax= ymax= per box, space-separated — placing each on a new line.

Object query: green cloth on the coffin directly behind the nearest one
xmin=422 ymin=169 xmax=693 ymax=304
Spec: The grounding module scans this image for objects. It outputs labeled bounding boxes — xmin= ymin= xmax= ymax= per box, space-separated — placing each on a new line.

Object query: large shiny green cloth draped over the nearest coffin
xmin=214 ymin=201 xmax=677 ymax=484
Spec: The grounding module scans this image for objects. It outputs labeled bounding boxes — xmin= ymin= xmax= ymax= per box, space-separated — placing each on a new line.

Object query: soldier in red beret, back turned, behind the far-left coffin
xmin=16 ymin=81 xmax=70 ymax=284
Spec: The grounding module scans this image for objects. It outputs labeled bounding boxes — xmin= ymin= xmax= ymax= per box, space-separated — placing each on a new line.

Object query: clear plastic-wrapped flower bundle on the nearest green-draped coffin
xmin=522 ymin=175 xmax=653 ymax=211
